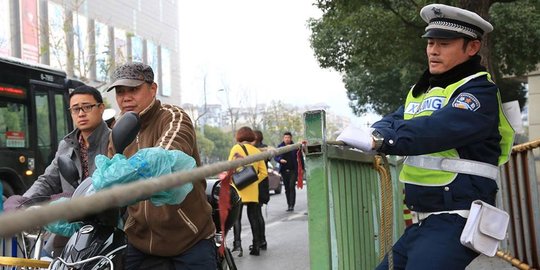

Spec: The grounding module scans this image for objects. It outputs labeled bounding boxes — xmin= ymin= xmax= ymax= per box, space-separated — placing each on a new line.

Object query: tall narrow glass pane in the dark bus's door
xmin=35 ymin=91 xmax=52 ymax=164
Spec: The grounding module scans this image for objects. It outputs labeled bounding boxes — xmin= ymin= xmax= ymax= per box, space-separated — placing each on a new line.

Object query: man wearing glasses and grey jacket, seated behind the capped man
xmin=6 ymin=85 xmax=110 ymax=256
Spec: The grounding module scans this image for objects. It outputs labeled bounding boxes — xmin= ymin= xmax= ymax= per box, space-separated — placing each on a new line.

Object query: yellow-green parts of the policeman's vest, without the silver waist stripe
xmin=399 ymin=72 xmax=514 ymax=186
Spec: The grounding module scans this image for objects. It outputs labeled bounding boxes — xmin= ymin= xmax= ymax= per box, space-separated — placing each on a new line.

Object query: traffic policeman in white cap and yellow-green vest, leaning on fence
xmin=338 ymin=4 xmax=514 ymax=270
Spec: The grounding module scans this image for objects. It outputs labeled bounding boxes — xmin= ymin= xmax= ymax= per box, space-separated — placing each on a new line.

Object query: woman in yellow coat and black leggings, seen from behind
xmin=229 ymin=127 xmax=268 ymax=257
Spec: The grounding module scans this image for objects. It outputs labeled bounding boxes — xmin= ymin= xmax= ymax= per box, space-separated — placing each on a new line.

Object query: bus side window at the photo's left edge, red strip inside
xmin=0 ymin=101 xmax=28 ymax=148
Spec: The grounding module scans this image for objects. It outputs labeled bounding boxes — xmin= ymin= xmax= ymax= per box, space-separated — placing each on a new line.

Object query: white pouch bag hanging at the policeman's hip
xmin=460 ymin=200 xmax=510 ymax=257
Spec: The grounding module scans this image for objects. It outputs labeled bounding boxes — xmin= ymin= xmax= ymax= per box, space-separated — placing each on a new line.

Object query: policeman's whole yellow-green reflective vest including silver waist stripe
xmin=399 ymin=72 xmax=514 ymax=186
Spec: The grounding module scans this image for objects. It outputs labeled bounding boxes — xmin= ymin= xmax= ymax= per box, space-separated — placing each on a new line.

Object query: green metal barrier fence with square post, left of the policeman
xmin=304 ymin=111 xmax=404 ymax=270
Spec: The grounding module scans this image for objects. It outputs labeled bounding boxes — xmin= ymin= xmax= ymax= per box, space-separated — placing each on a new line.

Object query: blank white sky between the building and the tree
xmin=179 ymin=0 xmax=376 ymax=125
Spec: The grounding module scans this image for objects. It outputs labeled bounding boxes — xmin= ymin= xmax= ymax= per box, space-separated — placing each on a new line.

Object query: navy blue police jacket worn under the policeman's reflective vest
xmin=372 ymin=56 xmax=508 ymax=212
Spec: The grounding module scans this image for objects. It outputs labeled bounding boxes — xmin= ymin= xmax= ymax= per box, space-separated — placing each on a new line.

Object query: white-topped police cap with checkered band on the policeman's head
xmin=420 ymin=4 xmax=493 ymax=39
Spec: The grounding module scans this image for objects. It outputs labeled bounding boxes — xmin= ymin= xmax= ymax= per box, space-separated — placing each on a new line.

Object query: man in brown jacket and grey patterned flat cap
xmin=107 ymin=63 xmax=216 ymax=270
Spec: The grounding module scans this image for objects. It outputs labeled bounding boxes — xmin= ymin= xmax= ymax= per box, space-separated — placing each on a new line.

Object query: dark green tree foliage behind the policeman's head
xmin=309 ymin=0 xmax=540 ymax=114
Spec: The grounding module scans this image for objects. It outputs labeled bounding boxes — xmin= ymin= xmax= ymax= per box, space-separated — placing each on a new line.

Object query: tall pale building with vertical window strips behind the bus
xmin=0 ymin=0 xmax=181 ymax=108
